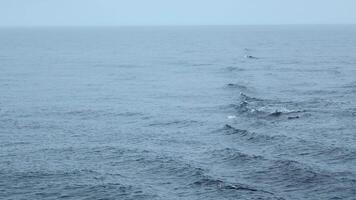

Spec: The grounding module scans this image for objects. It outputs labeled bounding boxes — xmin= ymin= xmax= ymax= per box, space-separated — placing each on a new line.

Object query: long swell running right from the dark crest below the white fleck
xmin=214 ymin=124 xmax=356 ymax=173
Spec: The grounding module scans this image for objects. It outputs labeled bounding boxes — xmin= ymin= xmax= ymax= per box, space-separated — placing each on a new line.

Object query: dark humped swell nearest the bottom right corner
xmin=248 ymin=159 xmax=356 ymax=193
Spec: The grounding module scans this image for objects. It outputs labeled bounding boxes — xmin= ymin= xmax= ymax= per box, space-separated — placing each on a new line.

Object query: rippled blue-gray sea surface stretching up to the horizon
xmin=0 ymin=25 xmax=356 ymax=200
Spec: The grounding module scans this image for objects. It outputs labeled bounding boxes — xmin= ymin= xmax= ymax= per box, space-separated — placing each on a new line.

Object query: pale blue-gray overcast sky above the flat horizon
xmin=0 ymin=0 xmax=356 ymax=26
